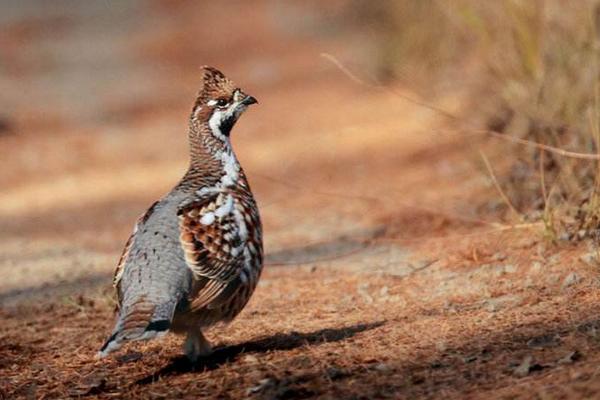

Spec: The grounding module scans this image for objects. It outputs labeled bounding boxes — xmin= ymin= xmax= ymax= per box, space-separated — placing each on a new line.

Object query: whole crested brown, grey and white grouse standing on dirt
xmin=98 ymin=66 xmax=263 ymax=362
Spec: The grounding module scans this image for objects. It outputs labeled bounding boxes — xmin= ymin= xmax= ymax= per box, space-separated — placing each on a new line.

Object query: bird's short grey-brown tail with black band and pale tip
xmin=97 ymin=304 xmax=171 ymax=358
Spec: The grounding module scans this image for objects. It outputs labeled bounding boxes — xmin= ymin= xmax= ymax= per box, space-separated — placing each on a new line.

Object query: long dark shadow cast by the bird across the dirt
xmin=136 ymin=321 xmax=385 ymax=385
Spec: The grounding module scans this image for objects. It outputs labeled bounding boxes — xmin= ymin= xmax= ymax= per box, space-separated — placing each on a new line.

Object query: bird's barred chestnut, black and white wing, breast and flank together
xmin=174 ymin=179 xmax=263 ymax=329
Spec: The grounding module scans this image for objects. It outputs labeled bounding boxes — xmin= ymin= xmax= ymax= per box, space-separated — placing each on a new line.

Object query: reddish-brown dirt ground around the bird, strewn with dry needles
xmin=0 ymin=1 xmax=600 ymax=399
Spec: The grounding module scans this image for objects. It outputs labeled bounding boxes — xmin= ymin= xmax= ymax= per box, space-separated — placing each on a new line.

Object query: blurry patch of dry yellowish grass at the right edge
xmin=372 ymin=0 xmax=600 ymax=238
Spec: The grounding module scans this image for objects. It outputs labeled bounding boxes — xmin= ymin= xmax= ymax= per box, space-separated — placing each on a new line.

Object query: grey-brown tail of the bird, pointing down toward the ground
xmin=97 ymin=299 xmax=174 ymax=358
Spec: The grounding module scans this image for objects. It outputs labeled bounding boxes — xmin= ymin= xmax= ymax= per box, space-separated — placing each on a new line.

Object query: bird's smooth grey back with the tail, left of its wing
xmin=101 ymin=192 xmax=192 ymax=351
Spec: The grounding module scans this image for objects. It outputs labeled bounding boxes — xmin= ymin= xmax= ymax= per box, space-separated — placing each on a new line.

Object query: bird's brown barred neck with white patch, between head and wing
xmin=179 ymin=122 xmax=245 ymax=190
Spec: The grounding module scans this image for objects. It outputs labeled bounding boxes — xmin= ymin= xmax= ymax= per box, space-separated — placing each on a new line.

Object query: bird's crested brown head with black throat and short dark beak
xmin=192 ymin=66 xmax=257 ymax=140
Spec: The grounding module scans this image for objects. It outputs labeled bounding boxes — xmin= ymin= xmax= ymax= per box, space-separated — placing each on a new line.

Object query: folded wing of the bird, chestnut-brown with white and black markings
xmin=177 ymin=192 xmax=247 ymax=310
